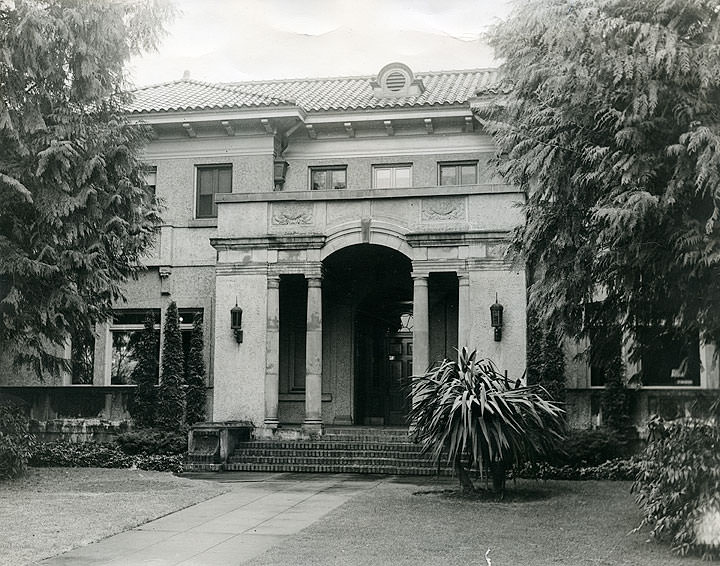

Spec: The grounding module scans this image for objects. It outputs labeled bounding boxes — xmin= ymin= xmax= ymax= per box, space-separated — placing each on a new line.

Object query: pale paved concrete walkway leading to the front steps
xmin=41 ymin=473 xmax=382 ymax=566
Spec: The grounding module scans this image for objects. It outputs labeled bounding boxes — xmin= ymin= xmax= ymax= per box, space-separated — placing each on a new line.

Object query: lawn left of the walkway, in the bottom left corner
xmin=0 ymin=468 xmax=227 ymax=566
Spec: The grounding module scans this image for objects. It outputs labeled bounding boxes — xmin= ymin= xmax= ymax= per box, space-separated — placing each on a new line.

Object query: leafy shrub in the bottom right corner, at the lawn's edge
xmin=633 ymin=418 xmax=720 ymax=559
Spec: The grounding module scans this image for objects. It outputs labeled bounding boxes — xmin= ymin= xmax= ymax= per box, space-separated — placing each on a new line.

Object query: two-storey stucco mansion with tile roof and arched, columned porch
xmin=0 ymin=63 xmax=720 ymax=434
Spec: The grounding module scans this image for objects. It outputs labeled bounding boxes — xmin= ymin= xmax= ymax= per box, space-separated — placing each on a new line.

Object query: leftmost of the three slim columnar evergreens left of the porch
xmin=130 ymin=315 xmax=159 ymax=427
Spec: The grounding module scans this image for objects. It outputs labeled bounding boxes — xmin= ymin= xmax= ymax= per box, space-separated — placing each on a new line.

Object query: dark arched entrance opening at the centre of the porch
xmin=323 ymin=244 xmax=413 ymax=425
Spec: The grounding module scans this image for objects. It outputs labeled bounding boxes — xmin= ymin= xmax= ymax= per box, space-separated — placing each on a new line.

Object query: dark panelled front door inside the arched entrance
xmin=385 ymin=332 xmax=412 ymax=426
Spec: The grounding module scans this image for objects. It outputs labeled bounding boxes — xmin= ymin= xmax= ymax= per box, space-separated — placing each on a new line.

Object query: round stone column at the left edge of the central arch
xmin=303 ymin=277 xmax=322 ymax=434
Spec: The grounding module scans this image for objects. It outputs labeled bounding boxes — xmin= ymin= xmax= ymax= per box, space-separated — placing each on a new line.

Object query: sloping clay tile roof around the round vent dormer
xmin=130 ymin=69 xmax=497 ymax=113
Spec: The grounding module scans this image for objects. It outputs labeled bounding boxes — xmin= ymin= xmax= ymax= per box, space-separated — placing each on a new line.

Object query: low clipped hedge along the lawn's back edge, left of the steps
xmin=30 ymin=441 xmax=184 ymax=473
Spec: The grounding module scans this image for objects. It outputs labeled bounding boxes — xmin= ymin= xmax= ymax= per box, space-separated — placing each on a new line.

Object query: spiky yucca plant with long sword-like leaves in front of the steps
xmin=410 ymin=348 xmax=564 ymax=493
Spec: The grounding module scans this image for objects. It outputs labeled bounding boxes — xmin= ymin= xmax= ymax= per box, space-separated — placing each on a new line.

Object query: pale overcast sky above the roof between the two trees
xmin=129 ymin=0 xmax=510 ymax=86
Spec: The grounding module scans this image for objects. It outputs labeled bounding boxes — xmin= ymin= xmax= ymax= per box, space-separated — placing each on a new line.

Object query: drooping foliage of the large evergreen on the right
xmin=478 ymin=0 xmax=720 ymax=364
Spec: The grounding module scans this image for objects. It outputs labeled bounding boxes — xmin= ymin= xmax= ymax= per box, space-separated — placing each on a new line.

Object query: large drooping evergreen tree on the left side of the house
xmin=0 ymin=0 xmax=171 ymax=377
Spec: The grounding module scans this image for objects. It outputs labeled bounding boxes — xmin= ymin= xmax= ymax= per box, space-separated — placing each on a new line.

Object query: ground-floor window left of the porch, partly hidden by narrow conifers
xmin=110 ymin=309 xmax=160 ymax=385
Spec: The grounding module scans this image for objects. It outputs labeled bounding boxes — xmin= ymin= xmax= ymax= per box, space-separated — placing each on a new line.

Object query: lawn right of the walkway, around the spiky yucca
xmin=243 ymin=480 xmax=704 ymax=566
